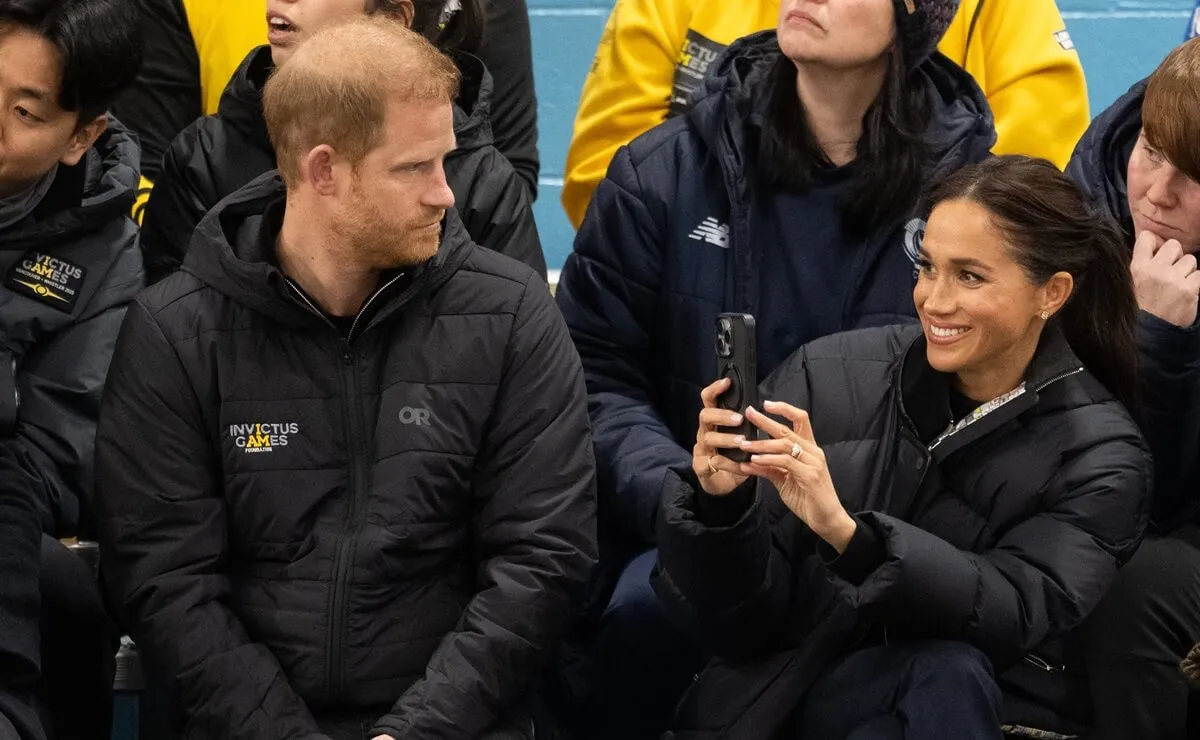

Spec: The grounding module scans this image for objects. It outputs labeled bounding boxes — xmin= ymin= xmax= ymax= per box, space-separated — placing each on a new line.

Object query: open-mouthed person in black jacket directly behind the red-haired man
xmin=142 ymin=0 xmax=546 ymax=284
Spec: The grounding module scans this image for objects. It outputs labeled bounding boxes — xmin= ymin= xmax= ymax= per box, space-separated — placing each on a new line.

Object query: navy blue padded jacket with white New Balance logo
xmin=558 ymin=31 xmax=995 ymax=556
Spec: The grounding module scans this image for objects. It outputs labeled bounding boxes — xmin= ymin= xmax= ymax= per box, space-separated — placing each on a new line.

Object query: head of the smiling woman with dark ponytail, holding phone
xmin=913 ymin=157 xmax=1138 ymax=405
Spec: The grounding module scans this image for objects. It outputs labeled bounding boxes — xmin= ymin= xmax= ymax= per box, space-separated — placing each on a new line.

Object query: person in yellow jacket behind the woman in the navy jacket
xmin=563 ymin=0 xmax=1091 ymax=228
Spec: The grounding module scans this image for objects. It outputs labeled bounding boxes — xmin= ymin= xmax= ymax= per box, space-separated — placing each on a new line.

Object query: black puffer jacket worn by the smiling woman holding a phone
xmin=655 ymin=326 xmax=1151 ymax=740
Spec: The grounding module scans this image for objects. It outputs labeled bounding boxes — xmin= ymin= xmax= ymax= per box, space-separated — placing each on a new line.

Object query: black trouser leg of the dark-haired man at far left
xmin=41 ymin=536 xmax=119 ymax=740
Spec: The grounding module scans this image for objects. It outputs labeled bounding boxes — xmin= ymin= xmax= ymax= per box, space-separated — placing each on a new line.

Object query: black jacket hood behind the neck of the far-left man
xmin=2 ymin=116 xmax=142 ymax=249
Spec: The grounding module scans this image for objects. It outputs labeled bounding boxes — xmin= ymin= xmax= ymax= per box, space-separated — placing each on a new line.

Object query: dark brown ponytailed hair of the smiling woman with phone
xmin=932 ymin=155 xmax=1138 ymax=410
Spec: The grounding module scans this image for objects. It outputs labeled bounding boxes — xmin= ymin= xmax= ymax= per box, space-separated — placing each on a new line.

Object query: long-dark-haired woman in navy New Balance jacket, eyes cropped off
xmin=547 ymin=0 xmax=995 ymax=739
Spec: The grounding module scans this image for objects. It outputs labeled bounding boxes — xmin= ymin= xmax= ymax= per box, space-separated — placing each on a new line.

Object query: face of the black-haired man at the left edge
xmin=0 ymin=25 xmax=100 ymax=198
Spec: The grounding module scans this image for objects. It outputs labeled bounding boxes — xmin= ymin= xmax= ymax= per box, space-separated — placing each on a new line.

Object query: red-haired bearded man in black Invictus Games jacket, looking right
xmin=96 ymin=18 xmax=595 ymax=740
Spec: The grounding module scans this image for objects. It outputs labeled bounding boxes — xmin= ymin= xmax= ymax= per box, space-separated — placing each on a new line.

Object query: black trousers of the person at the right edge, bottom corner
xmin=1082 ymin=525 xmax=1200 ymax=740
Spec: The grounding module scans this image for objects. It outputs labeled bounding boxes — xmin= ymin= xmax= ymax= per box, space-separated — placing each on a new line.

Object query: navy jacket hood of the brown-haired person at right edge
xmin=1067 ymin=79 xmax=1147 ymax=237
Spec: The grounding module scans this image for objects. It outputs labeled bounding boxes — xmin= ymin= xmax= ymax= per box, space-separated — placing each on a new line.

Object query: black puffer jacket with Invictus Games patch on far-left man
xmin=0 ymin=119 xmax=143 ymax=536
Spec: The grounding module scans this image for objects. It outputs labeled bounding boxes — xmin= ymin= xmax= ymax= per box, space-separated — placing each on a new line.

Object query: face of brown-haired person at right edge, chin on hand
xmin=1126 ymin=133 xmax=1200 ymax=254
